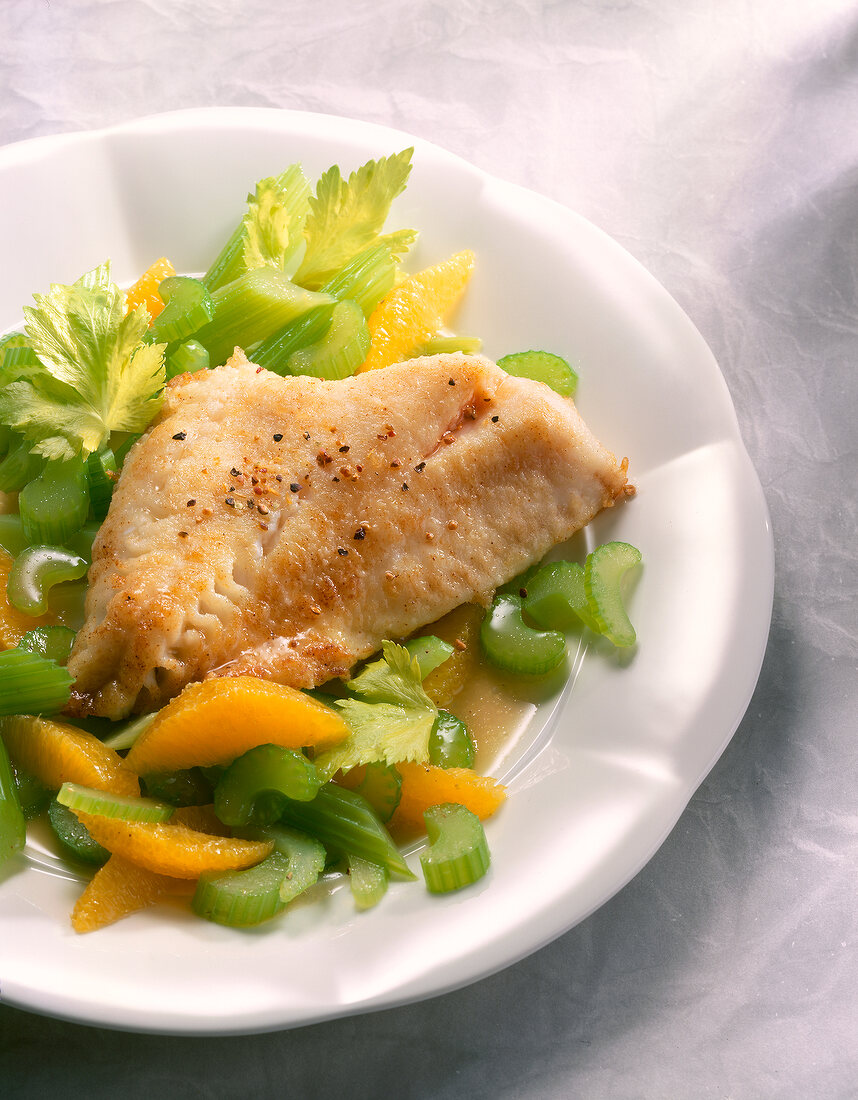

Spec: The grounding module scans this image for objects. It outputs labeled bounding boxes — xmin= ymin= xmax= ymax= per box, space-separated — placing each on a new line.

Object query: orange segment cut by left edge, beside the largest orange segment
xmin=0 ymin=714 xmax=140 ymax=795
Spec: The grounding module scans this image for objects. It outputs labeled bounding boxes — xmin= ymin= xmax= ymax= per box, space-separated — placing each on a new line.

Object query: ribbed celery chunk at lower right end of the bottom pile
xmin=420 ymin=802 xmax=491 ymax=893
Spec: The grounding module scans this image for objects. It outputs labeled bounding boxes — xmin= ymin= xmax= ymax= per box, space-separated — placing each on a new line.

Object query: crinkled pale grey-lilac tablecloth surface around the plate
xmin=0 ymin=0 xmax=858 ymax=1100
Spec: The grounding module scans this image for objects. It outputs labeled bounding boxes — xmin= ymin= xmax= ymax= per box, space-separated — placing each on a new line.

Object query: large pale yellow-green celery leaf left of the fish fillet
xmin=0 ymin=263 xmax=165 ymax=459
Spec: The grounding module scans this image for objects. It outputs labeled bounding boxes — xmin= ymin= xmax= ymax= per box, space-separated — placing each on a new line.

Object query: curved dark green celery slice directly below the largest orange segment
xmin=215 ymin=745 xmax=325 ymax=825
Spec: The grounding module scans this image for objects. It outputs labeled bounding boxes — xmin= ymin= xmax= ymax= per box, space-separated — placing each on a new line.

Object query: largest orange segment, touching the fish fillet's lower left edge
xmin=125 ymin=677 xmax=349 ymax=776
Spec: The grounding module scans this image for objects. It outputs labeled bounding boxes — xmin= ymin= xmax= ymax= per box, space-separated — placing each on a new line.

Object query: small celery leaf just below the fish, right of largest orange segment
xmin=314 ymin=641 xmax=438 ymax=777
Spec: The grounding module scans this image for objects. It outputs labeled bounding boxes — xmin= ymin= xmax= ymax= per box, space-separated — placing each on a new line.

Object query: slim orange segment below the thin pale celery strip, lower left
xmin=74 ymin=810 xmax=274 ymax=879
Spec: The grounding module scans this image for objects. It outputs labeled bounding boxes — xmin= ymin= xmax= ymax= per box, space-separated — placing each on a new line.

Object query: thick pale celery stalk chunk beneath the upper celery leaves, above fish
xmin=196 ymin=267 xmax=331 ymax=366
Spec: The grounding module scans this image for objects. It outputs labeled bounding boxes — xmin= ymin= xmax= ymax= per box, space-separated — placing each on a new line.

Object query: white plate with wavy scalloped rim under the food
xmin=0 ymin=109 xmax=772 ymax=1033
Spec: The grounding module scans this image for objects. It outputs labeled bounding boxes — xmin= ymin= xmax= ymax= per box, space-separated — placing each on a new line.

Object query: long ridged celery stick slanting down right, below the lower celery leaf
xmin=281 ymin=783 xmax=415 ymax=879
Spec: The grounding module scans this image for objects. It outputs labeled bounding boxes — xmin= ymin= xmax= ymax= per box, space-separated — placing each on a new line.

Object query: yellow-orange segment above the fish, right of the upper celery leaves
xmin=360 ymin=249 xmax=474 ymax=371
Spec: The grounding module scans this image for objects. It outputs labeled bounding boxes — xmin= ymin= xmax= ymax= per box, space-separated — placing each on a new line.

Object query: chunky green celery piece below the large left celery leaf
xmin=18 ymin=457 xmax=89 ymax=546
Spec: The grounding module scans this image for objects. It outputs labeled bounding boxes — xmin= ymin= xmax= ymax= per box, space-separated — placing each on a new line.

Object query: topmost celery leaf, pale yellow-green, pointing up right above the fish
xmin=295 ymin=149 xmax=414 ymax=289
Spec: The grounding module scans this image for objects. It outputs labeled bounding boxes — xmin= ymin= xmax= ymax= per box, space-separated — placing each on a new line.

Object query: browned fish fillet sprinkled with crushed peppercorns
xmin=68 ymin=353 xmax=627 ymax=718
